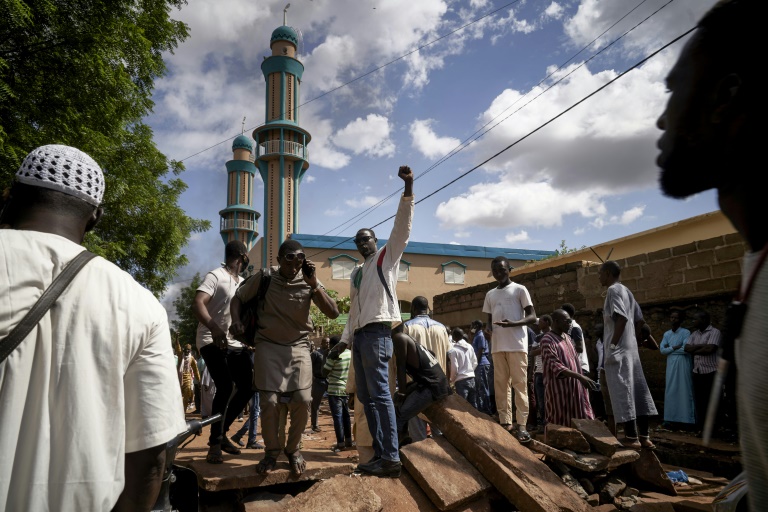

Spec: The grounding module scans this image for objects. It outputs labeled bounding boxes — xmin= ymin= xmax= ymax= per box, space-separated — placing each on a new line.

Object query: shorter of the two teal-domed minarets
xmin=219 ymin=133 xmax=259 ymax=250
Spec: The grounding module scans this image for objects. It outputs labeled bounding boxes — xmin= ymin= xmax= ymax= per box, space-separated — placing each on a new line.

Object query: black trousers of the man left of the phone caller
xmin=200 ymin=344 xmax=253 ymax=446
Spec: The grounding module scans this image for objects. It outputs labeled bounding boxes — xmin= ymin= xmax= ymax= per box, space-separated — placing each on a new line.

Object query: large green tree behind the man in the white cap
xmin=0 ymin=0 xmax=210 ymax=295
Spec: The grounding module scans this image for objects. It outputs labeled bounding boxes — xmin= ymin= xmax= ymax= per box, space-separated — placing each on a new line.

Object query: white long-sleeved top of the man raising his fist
xmin=341 ymin=196 xmax=414 ymax=345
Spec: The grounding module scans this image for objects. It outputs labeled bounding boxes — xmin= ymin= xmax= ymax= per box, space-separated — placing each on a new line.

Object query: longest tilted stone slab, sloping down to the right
xmin=424 ymin=394 xmax=588 ymax=512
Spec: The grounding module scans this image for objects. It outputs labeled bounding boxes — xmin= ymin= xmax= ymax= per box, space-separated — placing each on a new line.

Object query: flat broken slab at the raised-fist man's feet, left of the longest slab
xmin=400 ymin=436 xmax=491 ymax=510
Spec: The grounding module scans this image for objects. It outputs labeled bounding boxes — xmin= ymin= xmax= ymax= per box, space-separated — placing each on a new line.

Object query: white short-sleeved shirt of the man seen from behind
xmin=0 ymin=229 xmax=186 ymax=512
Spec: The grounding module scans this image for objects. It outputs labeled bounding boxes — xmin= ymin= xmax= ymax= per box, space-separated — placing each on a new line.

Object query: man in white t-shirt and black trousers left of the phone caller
xmin=192 ymin=240 xmax=254 ymax=464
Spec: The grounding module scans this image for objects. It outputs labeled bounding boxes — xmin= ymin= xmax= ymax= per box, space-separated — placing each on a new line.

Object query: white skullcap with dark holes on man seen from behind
xmin=16 ymin=144 xmax=104 ymax=206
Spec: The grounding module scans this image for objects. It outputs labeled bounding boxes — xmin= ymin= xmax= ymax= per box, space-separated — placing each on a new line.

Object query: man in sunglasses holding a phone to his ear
xmin=229 ymin=239 xmax=339 ymax=476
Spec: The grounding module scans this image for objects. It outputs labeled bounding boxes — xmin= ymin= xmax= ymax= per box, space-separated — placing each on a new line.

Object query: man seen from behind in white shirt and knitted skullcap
xmin=0 ymin=145 xmax=186 ymax=511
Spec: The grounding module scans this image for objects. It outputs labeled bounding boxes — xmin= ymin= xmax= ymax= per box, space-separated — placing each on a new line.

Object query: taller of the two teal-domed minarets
xmin=253 ymin=4 xmax=311 ymax=265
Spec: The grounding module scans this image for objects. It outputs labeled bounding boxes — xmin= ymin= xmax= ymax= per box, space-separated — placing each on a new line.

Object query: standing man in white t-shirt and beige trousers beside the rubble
xmin=483 ymin=256 xmax=536 ymax=443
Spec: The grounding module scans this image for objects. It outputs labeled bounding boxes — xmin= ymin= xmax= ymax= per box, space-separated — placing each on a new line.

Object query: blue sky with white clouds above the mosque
xmin=147 ymin=0 xmax=717 ymax=315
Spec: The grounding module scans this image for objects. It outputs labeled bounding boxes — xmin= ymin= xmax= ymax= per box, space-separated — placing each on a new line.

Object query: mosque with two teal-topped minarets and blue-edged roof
xmin=220 ymin=15 xmax=556 ymax=312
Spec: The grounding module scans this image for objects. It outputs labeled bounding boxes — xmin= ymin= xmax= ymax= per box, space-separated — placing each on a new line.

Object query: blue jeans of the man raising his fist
xmin=352 ymin=324 xmax=400 ymax=462
